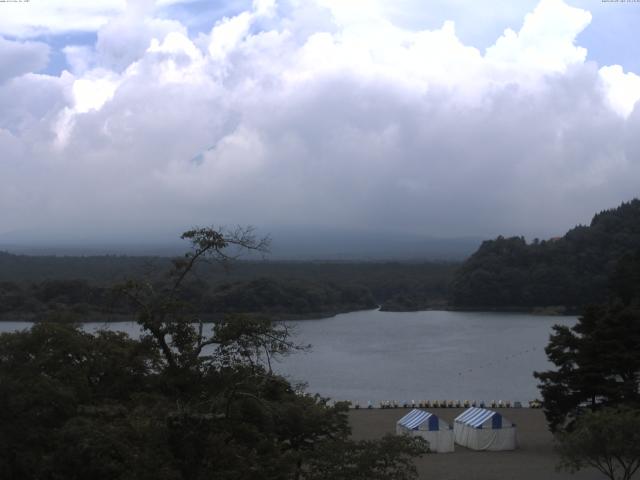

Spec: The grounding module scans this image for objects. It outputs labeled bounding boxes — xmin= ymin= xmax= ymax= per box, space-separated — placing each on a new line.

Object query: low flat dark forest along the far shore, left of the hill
xmin=0 ymin=253 xmax=455 ymax=321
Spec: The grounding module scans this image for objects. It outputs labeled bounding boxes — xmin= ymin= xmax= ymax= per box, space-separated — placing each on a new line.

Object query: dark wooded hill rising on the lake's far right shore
xmin=451 ymin=199 xmax=640 ymax=310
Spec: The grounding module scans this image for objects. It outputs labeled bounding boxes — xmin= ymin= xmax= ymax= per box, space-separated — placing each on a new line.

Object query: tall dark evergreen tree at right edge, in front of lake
xmin=535 ymin=251 xmax=640 ymax=431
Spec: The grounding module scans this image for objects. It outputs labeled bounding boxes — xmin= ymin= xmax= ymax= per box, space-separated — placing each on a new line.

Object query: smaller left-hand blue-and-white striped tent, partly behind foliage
xmin=396 ymin=408 xmax=453 ymax=453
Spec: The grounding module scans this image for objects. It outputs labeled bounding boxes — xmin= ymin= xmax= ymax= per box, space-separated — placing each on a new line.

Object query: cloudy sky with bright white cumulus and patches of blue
xmin=0 ymin=0 xmax=640 ymax=246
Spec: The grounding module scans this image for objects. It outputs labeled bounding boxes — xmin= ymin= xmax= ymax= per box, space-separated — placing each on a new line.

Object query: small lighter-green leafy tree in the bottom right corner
xmin=557 ymin=408 xmax=640 ymax=480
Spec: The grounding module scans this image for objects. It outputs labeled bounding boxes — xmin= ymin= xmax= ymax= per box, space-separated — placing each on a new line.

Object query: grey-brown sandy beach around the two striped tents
xmin=350 ymin=408 xmax=604 ymax=480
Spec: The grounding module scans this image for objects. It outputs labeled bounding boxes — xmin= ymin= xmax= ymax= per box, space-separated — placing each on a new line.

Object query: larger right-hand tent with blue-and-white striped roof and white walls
xmin=453 ymin=407 xmax=516 ymax=450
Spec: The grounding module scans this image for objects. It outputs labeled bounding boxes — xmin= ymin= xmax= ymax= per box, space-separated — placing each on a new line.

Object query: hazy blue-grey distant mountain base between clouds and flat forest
xmin=0 ymin=227 xmax=483 ymax=261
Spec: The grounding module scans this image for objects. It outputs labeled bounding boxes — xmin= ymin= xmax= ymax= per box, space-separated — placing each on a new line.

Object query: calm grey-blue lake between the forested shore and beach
xmin=0 ymin=310 xmax=576 ymax=405
